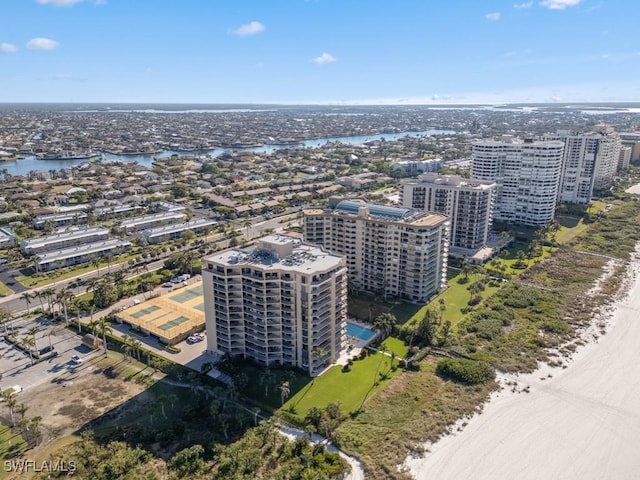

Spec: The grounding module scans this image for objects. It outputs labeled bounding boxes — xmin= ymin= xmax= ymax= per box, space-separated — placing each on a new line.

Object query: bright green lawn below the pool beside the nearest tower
xmin=283 ymin=353 xmax=401 ymax=419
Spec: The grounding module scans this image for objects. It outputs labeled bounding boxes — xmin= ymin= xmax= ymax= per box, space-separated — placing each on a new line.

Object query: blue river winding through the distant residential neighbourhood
xmin=0 ymin=130 xmax=455 ymax=175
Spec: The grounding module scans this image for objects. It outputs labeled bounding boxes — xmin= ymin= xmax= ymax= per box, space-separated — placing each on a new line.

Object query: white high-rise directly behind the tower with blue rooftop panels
xmin=400 ymin=173 xmax=496 ymax=250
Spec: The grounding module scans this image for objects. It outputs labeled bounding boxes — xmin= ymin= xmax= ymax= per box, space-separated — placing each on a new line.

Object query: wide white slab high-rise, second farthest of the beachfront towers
xmin=471 ymin=140 xmax=564 ymax=227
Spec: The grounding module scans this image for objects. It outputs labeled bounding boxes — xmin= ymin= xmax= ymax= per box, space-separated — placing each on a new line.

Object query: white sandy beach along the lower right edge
xmin=406 ymin=253 xmax=640 ymax=480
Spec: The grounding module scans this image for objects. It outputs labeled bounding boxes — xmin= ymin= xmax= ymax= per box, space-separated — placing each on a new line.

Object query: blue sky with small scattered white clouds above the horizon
xmin=0 ymin=0 xmax=640 ymax=104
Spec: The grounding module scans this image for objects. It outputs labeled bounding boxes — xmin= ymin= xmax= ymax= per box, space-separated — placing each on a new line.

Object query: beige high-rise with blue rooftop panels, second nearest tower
xmin=304 ymin=198 xmax=449 ymax=303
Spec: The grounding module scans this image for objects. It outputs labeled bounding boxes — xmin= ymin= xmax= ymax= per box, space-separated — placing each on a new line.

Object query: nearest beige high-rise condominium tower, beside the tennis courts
xmin=202 ymin=235 xmax=347 ymax=375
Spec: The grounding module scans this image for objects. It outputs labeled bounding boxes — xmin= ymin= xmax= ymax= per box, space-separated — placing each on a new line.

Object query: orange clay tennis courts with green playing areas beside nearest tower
xmin=118 ymin=282 xmax=205 ymax=345
